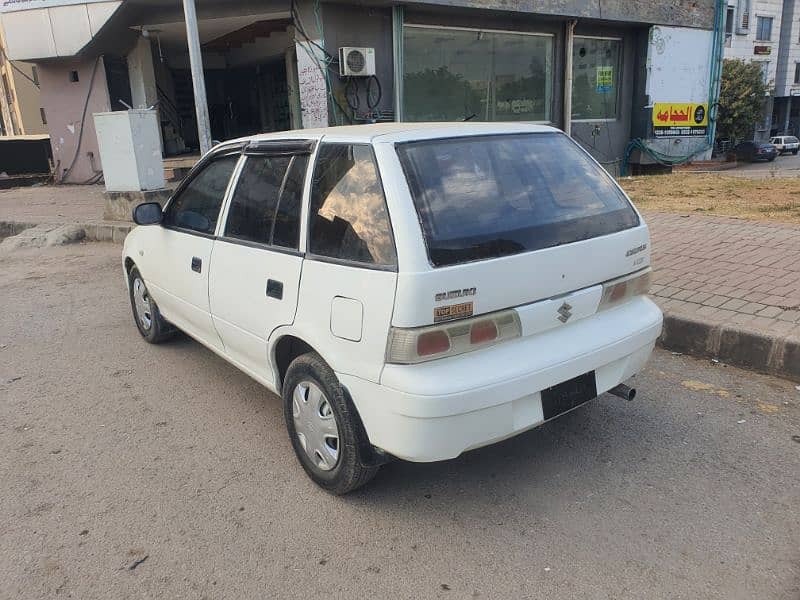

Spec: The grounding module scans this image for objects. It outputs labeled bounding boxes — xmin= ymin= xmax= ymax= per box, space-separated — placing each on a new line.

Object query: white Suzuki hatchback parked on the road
xmin=124 ymin=123 xmax=662 ymax=493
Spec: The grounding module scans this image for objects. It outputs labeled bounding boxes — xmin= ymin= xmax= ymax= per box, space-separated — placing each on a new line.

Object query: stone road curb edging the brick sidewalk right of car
xmin=659 ymin=311 xmax=800 ymax=381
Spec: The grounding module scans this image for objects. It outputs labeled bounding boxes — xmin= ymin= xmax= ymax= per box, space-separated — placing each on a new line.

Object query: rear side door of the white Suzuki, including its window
xmin=209 ymin=141 xmax=312 ymax=381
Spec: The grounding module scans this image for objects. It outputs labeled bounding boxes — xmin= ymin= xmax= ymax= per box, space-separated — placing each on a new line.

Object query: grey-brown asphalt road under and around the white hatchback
xmin=0 ymin=244 xmax=800 ymax=600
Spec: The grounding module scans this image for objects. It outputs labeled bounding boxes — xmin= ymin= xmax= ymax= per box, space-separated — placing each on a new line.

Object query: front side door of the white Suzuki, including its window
xmin=141 ymin=152 xmax=239 ymax=348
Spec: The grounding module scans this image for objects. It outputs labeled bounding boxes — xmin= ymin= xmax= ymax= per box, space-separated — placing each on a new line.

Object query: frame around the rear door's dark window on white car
xmin=215 ymin=139 xmax=320 ymax=257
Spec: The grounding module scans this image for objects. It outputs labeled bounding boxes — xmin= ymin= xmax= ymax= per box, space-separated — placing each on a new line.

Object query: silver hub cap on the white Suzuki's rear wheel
xmin=292 ymin=381 xmax=339 ymax=471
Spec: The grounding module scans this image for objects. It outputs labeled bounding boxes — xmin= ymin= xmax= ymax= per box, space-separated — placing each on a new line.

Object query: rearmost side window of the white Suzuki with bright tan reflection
xmin=309 ymin=144 xmax=397 ymax=266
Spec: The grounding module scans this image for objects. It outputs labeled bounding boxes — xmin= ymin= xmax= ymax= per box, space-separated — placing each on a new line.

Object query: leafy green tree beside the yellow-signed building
xmin=717 ymin=59 xmax=770 ymax=143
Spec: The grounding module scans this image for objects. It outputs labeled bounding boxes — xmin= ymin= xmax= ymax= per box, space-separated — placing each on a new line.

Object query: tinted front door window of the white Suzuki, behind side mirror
xmin=164 ymin=155 xmax=239 ymax=235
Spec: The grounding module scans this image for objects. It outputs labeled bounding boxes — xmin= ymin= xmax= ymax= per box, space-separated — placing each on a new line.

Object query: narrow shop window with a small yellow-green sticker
xmin=572 ymin=37 xmax=622 ymax=120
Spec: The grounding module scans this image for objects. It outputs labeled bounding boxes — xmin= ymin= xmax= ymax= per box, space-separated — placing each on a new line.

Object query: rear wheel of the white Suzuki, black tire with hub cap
xmin=282 ymin=352 xmax=379 ymax=495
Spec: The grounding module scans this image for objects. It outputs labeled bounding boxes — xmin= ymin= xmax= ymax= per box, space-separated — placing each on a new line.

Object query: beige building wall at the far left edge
xmin=0 ymin=28 xmax=47 ymax=136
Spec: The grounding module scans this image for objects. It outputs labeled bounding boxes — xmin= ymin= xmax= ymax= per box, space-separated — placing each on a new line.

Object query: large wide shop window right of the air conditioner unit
xmin=403 ymin=25 xmax=553 ymax=121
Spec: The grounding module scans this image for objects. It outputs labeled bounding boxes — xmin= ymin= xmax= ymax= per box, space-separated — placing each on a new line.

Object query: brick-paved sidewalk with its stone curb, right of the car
xmin=646 ymin=213 xmax=800 ymax=380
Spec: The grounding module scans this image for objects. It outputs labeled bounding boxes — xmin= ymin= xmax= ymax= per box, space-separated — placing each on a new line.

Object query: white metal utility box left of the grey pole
xmin=94 ymin=110 xmax=164 ymax=192
